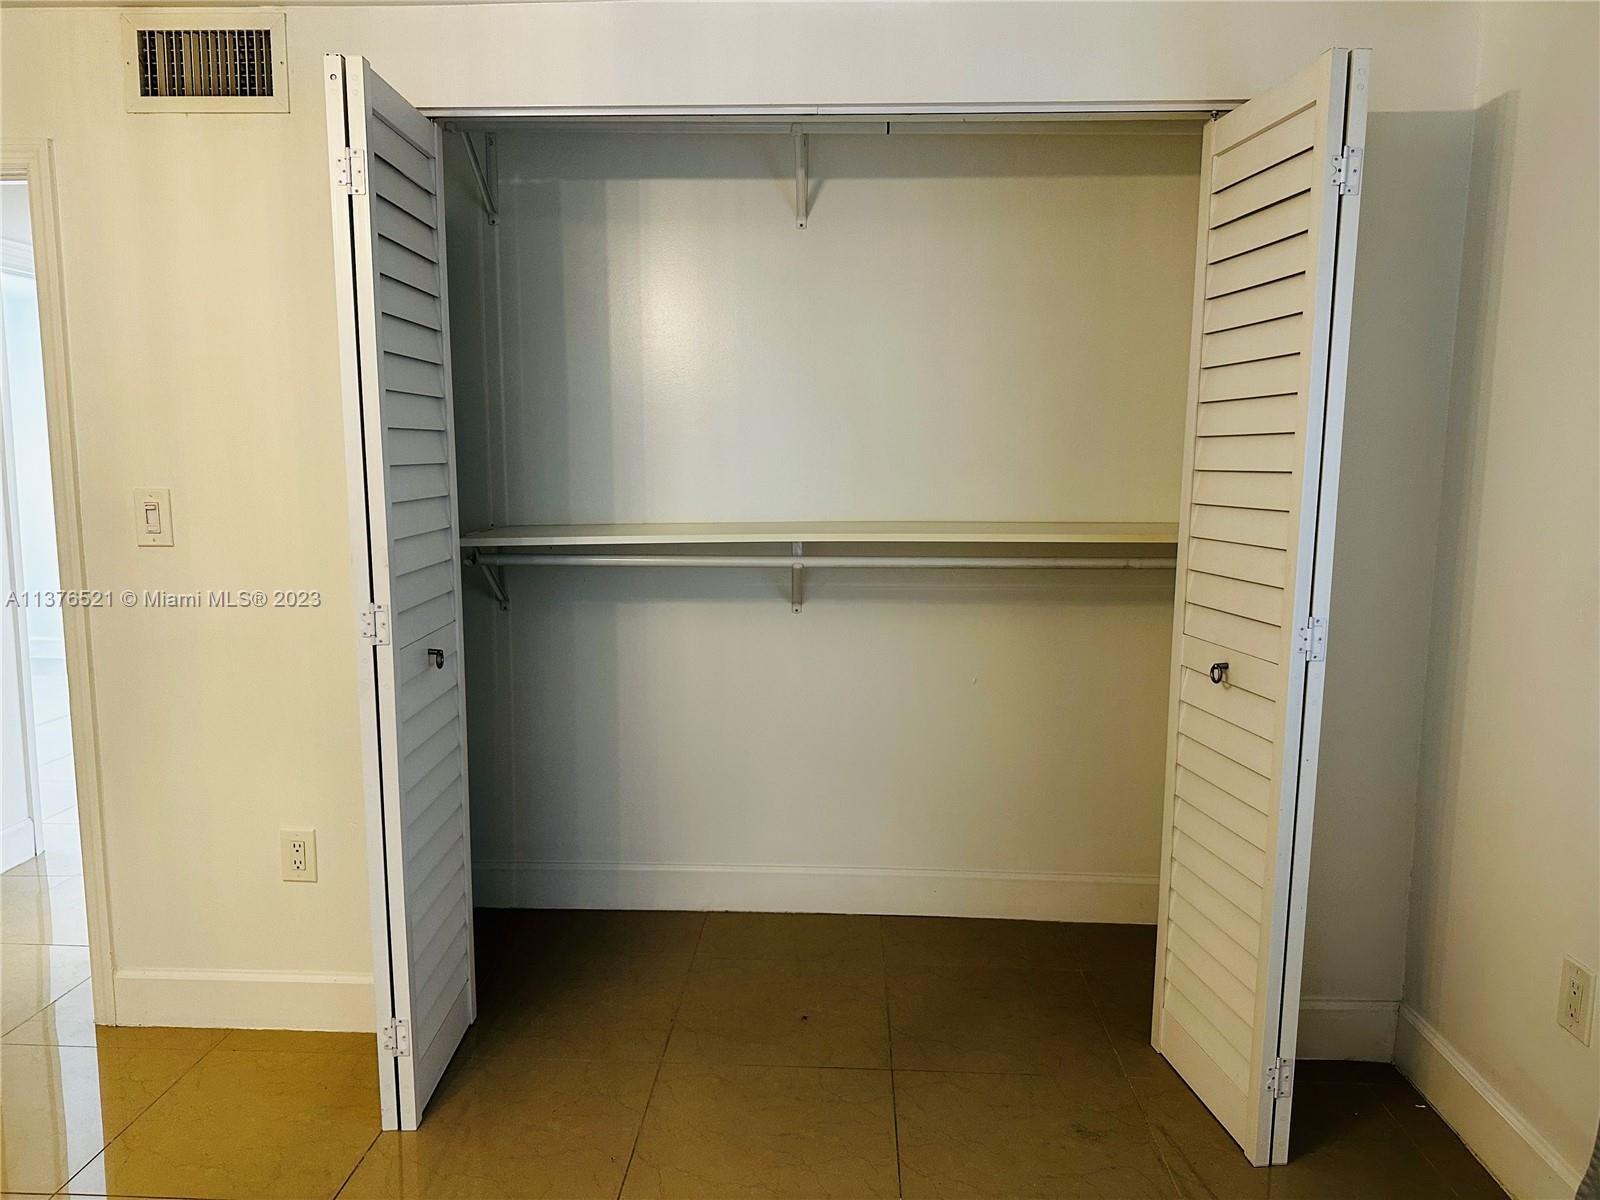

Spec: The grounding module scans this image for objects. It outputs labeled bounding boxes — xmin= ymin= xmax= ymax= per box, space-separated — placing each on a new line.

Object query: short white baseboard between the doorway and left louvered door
xmin=115 ymin=968 xmax=376 ymax=1032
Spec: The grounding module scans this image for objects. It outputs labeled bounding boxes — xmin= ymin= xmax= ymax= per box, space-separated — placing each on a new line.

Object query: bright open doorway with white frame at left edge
xmin=0 ymin=142 xmax=115 ymax=1042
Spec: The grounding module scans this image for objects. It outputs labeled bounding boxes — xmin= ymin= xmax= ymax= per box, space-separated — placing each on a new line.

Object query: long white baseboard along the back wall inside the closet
xmin=472 ymin=861 xmax=1160 ymax=925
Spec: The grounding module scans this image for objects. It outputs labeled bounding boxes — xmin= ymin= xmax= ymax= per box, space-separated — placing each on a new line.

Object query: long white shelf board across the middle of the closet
xmin=461 ymin=522 xmax=1178 ymax=549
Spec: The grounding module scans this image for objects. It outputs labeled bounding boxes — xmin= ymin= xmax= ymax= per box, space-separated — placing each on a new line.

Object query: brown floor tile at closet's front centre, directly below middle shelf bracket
xmin=667 ymin=958 xmax=890 ymax=1067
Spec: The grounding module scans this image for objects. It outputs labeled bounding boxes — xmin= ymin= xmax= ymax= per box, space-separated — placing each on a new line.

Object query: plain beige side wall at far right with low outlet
xmin=1400 ymin=5 xmax=1600 ymax=1197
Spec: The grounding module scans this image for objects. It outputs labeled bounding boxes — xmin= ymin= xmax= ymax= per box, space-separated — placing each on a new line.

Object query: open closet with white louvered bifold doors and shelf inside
xmin=325 ymin=50 xmax=1368 ymax=1163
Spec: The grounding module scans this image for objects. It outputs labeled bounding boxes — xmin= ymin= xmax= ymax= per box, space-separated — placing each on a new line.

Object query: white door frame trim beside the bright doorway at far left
xmin=0 ymin=139 xmax=117 ymax=1026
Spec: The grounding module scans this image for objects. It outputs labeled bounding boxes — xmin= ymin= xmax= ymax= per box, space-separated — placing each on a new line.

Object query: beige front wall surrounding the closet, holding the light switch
xmin=0 ymin=3 xmax=1477 ymax=1043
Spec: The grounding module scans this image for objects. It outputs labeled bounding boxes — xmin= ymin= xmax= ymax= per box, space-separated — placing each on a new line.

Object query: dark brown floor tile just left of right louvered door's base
xmin=890 ymin=966 xmax=1120 ymax=1077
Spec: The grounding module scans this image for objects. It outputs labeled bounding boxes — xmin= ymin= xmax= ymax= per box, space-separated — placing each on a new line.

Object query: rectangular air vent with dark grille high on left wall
xmin=123 ymin=13 xmax=290 ymax=112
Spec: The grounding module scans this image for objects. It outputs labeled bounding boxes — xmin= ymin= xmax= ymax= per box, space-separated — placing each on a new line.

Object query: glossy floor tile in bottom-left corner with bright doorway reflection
xmin=0 ymin=1045 xmax=205 ymax=1192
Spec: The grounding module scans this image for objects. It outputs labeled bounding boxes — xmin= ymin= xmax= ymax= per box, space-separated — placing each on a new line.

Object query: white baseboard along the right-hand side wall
xmin=1395 ymin=1005 xmax=1582 ymax=1200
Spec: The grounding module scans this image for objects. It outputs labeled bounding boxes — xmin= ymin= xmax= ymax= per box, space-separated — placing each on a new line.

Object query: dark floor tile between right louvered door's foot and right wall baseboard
xmin=1270 ymin=1082 xmax=1453 ymax=1200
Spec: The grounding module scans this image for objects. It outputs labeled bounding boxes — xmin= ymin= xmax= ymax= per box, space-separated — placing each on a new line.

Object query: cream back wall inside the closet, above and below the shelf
xmin=448 ymin=126 xmax=1198 ymax=920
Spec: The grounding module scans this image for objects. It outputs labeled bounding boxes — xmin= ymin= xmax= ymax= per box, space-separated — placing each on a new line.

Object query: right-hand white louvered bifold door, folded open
xmin=1152 ymin=50 xmax=1368 ymax=1165
